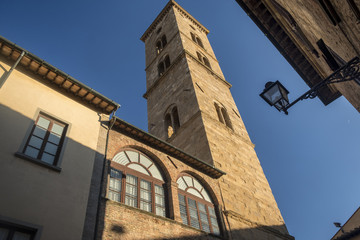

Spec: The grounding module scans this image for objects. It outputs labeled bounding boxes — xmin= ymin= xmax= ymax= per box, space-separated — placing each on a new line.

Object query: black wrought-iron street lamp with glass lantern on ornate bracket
xmin=260 ymin=57 xmax=360 ymax=115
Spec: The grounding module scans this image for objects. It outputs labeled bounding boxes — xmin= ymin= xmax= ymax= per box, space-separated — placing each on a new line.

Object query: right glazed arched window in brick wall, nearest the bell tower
xmin=176 ymin=175 xmax=220 ymax=234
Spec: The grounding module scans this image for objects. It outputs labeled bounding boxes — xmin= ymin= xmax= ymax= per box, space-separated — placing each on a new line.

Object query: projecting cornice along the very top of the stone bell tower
xmin=140 ymin=0 xmax=209 ymax=42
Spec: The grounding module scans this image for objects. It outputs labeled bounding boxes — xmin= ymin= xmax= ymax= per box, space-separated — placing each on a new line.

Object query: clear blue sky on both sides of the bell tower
xmin=0 ymin=0 xmax=360 ymax=240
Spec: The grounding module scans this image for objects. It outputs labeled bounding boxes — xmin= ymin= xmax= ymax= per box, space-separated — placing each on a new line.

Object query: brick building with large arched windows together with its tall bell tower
xmin=93 ymin=0 xmax=293 ymax=239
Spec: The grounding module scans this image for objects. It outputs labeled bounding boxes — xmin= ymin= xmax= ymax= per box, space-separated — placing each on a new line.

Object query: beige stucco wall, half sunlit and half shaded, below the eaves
xmin=0 ymin=59 xmax=100 ymax=240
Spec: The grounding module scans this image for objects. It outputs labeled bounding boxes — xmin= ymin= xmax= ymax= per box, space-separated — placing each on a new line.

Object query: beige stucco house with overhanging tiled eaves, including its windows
xmin=0 ymin=38 xmax=118 ymax=240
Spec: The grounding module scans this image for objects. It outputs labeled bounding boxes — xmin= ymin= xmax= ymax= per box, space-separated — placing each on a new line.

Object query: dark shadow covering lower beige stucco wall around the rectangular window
xmin=0 ymin=103 xmax=106 ymax=240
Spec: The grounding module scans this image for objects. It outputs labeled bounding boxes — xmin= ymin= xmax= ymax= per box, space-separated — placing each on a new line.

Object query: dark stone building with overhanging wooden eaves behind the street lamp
xmin=237 ymin=0 xmax=360 ymax=111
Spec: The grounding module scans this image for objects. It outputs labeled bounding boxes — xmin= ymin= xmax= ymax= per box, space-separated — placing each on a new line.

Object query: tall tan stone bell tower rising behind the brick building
xmin=141 ymin=0 xmax=293 ymax=239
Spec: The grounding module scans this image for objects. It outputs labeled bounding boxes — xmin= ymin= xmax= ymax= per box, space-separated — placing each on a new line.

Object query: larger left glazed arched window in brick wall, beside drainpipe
xmin=108 ymin=150 xmax=166 ymax=217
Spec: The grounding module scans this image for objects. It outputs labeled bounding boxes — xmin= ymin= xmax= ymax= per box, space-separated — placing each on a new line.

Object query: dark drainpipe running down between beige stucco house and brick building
xmin=94 ymin=105 xmax=120 ymax=240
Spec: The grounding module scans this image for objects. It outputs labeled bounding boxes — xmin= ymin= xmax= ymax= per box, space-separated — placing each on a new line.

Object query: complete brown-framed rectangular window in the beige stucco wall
xmin=23 ymin=114 xmax=68 ymax=166
